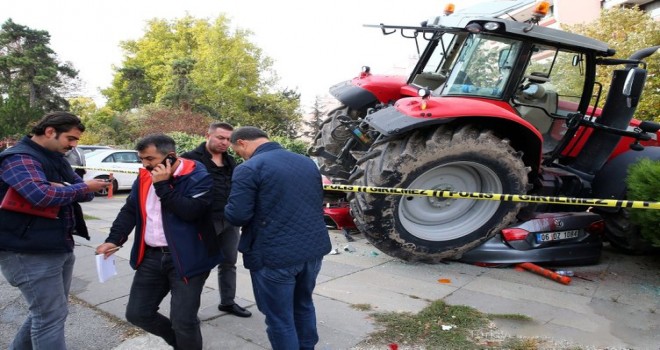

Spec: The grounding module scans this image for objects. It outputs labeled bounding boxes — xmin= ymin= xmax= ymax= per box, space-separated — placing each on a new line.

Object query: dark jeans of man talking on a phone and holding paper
xmin=126 ymin=250 xmax=209 ymax=350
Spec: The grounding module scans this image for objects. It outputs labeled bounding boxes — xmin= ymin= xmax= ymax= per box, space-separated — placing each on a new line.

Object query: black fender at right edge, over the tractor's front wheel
xmin=591 ymin=147 xmax=660 ymax=213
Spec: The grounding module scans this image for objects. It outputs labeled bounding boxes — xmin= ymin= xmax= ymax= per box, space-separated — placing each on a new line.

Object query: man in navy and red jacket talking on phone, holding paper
xmin=96 ymin=134 xmax=221 ymax=349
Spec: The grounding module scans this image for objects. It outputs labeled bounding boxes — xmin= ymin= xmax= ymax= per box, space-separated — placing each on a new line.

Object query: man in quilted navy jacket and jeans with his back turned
xmin=225 ymin=126 xmax=331 ymax=350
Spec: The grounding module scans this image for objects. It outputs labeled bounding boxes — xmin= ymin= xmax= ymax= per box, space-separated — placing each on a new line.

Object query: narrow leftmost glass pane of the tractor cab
xmin=412 ymin=33 xmax=465 ymax=90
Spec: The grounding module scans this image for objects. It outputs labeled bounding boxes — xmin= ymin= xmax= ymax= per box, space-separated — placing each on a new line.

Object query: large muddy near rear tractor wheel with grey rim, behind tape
xmin=350 ymin=125 xmax=528 ymax=263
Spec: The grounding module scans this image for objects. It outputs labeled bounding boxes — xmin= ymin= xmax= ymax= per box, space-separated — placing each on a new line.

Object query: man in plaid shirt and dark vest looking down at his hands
xmin=0 ymin=112 xmax=108 ymax=349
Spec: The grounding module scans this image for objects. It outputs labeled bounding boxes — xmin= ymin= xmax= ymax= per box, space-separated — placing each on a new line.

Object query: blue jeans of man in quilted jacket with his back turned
xmin=250 ymin=258 xmax=323 ymax=350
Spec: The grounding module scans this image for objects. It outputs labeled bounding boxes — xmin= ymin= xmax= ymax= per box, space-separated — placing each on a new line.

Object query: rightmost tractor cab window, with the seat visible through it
xmin=514 ymin=45 xmax=585 ymax=153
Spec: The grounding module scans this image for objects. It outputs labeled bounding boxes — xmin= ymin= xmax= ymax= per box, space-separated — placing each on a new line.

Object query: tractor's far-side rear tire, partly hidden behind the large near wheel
xmin=309 ymin=104 xmax=367 ymax=183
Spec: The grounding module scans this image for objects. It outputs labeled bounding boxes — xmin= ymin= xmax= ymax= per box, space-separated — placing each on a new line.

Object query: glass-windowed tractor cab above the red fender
xmin=398 ymin=19 xmax=612 ymax=154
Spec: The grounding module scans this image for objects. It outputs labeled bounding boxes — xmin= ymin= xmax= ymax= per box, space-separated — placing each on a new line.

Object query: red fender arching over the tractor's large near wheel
xmin=365 ymin=97 xmax=543 ymax=174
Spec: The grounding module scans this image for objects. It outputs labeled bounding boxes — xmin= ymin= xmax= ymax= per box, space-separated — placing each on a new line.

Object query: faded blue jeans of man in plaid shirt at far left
xmin=0 ymin=251 xmax=76 ymax=350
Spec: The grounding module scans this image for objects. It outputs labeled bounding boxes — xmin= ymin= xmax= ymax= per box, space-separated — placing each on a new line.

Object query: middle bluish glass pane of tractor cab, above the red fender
xmin=442 ymin=34 xmax=521 ymax=98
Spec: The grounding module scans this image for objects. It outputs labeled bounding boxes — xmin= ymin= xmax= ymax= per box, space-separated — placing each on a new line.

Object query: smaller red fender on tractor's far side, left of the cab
xmin=330 ymin=74 xmax=406 ymax=110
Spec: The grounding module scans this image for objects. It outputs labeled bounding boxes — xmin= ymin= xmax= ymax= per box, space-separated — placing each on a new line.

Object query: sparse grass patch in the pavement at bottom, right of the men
xmin=365 ymin=300 xmax=490 ymax=349
